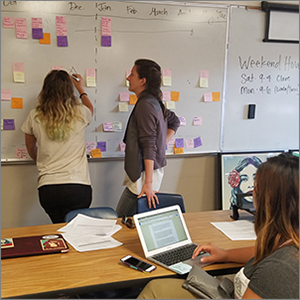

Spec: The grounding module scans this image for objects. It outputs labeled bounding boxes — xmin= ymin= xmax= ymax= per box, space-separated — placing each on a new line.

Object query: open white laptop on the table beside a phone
xmin=133 ymin=205 xmax=210 ymax=274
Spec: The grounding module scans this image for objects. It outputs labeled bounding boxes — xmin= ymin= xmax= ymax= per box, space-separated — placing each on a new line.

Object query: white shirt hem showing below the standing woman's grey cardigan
xmin=123 ymin=168 xmax=164 ymax=195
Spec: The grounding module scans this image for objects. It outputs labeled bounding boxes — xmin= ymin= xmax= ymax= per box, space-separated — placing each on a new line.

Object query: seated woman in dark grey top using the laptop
xmin=138 ymin=154 xmax=299 ymax=299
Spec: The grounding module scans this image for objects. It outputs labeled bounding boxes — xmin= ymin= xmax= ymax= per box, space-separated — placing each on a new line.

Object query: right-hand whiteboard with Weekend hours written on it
xmin=221 ymin=7 xmax=299 ymax=152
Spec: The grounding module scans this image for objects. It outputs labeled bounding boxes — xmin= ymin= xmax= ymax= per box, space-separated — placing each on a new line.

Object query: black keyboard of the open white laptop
xmin=152 ymin=244 xmax=197 ymax=266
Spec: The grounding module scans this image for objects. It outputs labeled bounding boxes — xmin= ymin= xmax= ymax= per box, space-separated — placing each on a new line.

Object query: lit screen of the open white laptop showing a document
xmin=138 ymin=209 xmax=188 ymax=252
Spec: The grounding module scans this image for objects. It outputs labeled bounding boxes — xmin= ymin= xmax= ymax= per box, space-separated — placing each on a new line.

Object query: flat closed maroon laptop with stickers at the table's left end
xmin=1 ymin=234 xmax=69 ymax=258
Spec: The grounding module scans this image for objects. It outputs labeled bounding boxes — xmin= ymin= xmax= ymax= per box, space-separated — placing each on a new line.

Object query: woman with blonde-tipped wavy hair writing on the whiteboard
xmin=21 ymin=70 xmax=93 ymax=223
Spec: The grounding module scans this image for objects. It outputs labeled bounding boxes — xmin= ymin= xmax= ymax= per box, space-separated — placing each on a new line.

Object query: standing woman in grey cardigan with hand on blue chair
xmin=116 ymin=59 xmax=180 ymax=216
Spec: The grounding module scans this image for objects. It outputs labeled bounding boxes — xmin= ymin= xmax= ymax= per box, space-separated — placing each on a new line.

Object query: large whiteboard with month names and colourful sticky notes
xmin=1 ymin=1 xmax=228 ymax=160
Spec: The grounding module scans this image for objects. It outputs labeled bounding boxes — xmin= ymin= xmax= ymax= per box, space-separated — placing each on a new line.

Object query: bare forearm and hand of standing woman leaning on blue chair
xmin=138 ymin=159 xmax=159 ymax=208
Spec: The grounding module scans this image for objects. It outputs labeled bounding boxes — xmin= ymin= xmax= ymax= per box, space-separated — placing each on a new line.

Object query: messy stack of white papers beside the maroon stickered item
xmin=58 ymin=214 xmax=122 ymax=252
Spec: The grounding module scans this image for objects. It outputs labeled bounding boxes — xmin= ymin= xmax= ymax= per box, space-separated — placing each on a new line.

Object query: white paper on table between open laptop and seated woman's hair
xmin=211 ymin=220 xmax=256 ymax=241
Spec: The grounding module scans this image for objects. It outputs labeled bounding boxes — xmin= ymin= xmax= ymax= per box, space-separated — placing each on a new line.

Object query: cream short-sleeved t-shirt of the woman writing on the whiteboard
xmin=21 ymin=104 xmax=92 ymax=187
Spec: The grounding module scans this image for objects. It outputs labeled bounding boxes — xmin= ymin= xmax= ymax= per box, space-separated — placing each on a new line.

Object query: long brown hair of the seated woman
xmin=253 ymin=153 xmax=299 ymax=264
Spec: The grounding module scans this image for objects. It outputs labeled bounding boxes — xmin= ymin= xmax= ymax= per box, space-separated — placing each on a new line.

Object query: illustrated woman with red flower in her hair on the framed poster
xmin=228 ymin=156 xmax=262 ymax=208
